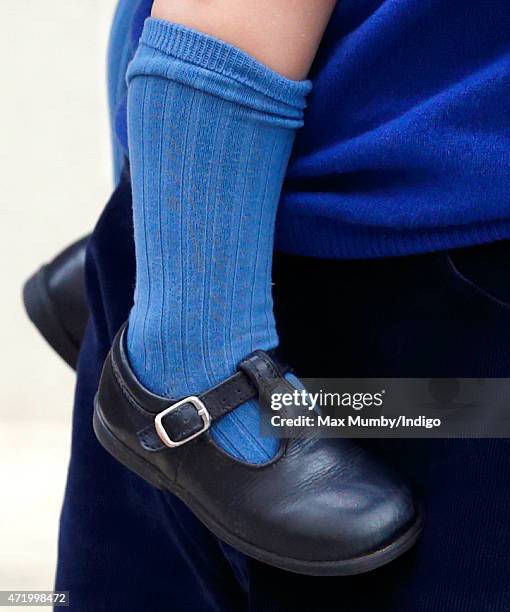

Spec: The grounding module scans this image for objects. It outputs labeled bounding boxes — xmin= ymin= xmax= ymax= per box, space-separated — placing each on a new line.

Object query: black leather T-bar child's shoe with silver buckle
xmin=94 ymin=327 xmax=421 ymax=576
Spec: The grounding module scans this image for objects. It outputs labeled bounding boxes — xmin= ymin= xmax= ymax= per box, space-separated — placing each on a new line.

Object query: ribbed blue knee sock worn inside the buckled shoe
xmin=127 ymin=19 xmax=310 ymax=463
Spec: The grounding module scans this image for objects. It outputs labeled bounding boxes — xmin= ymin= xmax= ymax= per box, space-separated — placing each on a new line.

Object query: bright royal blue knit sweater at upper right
xmin=117 ymin=0 xmax=510 ymax=258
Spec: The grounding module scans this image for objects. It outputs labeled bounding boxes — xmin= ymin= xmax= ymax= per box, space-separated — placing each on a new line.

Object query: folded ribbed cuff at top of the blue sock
xmin=127 ymin=18 xmax=311 ymax=127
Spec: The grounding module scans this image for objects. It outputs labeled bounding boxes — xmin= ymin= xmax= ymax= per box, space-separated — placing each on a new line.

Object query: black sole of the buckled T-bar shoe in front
xmin=93 ymin=396 xmax=423 ymax=576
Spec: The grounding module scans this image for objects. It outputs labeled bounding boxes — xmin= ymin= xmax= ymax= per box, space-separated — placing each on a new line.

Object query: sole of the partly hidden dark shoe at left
xmin=23 ymin=266 xmax=79 ymax=369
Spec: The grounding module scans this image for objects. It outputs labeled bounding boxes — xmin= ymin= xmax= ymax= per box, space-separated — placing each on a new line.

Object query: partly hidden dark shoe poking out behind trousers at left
xmin=23 ymin=236 xmax=89 ymax=369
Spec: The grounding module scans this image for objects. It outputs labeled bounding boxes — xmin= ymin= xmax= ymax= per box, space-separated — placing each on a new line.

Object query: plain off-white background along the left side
xmin=0 ymin=0 xmax=115 ymax=596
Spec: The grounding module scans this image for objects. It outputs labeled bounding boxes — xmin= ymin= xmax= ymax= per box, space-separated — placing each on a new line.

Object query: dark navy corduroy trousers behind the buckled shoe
xmin=56 ymin=175 xmax=510 ymax=612
